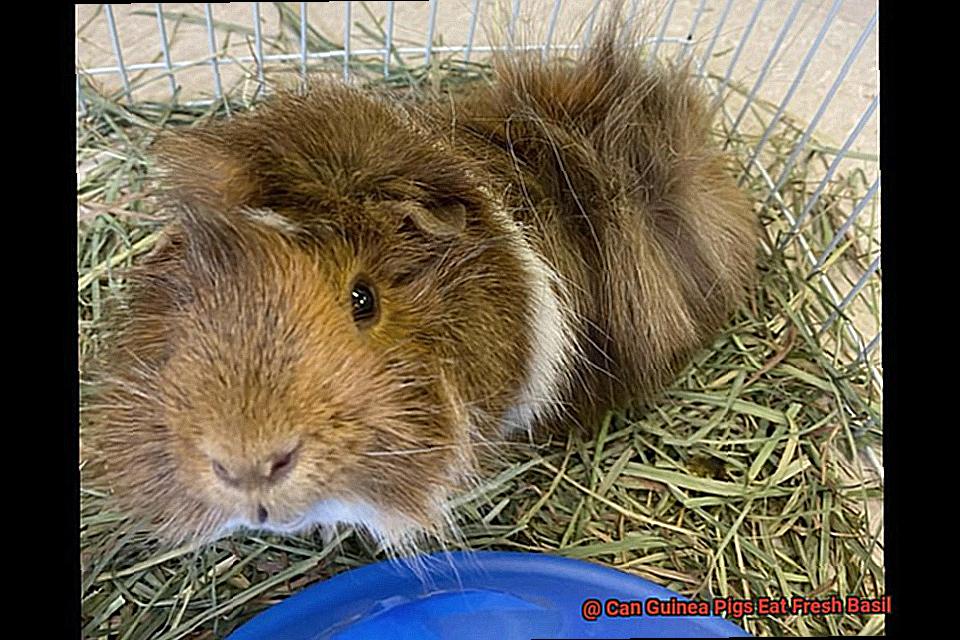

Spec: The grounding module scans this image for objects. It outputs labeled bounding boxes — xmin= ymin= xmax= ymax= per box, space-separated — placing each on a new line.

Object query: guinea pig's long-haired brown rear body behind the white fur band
xmin=434 ymin=30 xmax=758 ymax=419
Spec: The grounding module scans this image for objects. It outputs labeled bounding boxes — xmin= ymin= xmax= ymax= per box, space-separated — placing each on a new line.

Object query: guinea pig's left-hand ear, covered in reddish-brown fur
xmin=151 ymin=130 xmax=259 ymax=211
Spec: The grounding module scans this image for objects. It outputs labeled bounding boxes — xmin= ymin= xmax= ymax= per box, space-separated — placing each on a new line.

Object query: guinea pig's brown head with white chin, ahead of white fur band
xmin=83 ymin=87 xmax=531 ymax=548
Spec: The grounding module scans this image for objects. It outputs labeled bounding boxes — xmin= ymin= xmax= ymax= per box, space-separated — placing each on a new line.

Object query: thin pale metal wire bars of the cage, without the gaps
xmin=77 ymin=0 xmax=883 ymax=464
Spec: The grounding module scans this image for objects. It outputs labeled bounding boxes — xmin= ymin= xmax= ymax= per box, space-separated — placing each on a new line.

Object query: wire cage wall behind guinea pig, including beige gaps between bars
xmin=76 ymin=0 xmax=882 ymax=444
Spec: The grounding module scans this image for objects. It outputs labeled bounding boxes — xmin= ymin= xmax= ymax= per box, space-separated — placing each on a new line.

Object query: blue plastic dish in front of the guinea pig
xmin=228 ymin=551 xmax=749 ymax=640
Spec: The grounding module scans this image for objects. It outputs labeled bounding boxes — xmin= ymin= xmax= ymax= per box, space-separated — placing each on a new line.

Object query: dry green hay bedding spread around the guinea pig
xmin=77 ymin=18 xmax=884 ymax=640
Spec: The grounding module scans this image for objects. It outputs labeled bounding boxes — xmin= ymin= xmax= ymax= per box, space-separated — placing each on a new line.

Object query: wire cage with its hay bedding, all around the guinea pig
xmin=76 ymin=0 xmax=884 ymax=638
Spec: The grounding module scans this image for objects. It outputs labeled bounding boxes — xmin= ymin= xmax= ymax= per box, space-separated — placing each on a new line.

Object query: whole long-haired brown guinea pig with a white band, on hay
xmin=84 ymin=31 xmax=757 ymax=549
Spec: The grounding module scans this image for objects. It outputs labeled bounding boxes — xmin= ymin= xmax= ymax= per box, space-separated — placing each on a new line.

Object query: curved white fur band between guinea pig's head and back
xmin=488 ymin=193 xmax=575 ymax=433
